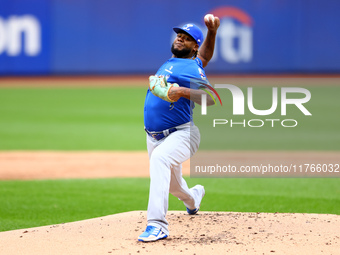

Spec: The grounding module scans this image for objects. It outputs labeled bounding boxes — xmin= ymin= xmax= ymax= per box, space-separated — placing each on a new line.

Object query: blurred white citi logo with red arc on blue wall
xmin=209 ymin=6 xmax=254 ymax=64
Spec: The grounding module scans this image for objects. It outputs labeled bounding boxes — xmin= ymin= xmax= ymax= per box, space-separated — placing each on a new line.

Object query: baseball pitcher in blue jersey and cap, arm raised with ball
xmin=138 ymin=14 xmax=220 ymax=242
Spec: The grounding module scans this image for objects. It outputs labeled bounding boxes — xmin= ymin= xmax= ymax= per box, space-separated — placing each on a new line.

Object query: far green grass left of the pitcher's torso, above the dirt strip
xmin=0 ymin=88 xmax=146 ymax=150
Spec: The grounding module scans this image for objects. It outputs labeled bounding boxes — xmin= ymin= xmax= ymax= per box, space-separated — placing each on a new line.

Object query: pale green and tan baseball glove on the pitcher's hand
xmin=149 ymin=75 xmax=179 ymax=103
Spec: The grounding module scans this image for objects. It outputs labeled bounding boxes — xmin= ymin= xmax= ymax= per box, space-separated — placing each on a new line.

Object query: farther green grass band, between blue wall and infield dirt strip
xmin=0 ymin=87 xmax=340 ymax=150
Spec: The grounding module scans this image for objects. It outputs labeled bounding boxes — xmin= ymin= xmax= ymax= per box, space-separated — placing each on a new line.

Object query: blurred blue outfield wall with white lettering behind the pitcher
xmin=0 ymin=0 xmax=340 ymax=76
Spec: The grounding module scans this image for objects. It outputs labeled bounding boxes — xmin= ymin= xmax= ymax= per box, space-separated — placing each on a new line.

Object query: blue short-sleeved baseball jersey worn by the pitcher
xmin=144 ymin=58 xmax=207 ymax=132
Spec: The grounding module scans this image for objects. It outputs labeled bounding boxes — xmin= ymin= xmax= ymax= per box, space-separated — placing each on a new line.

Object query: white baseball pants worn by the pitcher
xmin=147 ymin=122 xmax=202 ymax=235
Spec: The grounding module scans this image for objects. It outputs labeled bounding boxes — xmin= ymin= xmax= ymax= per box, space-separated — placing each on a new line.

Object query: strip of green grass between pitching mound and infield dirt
xmin=0 ymin=178 xmax=340 ymax=231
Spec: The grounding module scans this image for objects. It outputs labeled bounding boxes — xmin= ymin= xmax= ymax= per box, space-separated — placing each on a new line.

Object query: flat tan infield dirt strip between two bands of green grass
xmin=0 ymin=151 xmax=340 ymax=180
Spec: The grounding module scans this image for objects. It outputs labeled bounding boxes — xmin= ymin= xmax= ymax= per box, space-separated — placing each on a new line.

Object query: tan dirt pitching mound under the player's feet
xmin=0 ymin=211 xmax=340 ymax=255
